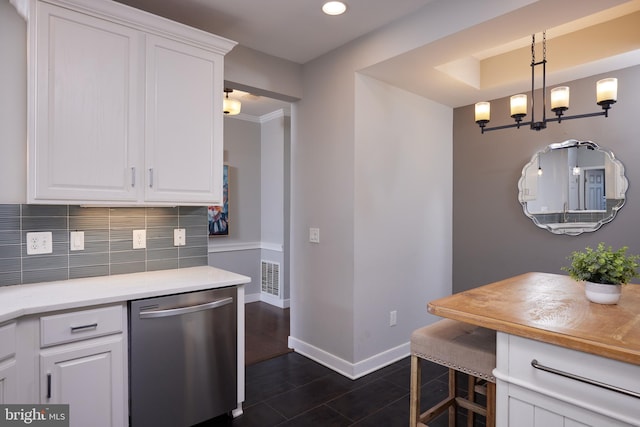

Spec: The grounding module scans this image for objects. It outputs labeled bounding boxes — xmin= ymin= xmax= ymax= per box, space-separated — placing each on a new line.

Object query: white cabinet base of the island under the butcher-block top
xmin=494 ymin=333 xmax=640 ymax=427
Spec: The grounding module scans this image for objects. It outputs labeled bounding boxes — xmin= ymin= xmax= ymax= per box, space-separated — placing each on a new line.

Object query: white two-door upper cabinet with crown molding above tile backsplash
xmin=18 ymin=0 xmax=235 ymax=205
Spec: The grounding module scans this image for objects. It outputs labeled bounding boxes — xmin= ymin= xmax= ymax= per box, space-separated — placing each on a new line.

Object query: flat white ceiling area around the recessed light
xmin=118 ymin=0 xmax=433 ymax=64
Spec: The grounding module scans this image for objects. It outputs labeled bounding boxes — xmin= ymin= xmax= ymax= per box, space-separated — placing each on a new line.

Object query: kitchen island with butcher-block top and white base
xmin=428 ymin=273 xmax=640 ymax=427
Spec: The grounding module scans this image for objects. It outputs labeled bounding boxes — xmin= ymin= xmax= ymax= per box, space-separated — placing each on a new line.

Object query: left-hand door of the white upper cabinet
xmin=28 ymin=2 xmax=143 ymax=203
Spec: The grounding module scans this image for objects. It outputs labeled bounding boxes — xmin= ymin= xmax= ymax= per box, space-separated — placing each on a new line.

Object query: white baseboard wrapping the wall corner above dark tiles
xmin=288 ymin=336 xmax=410 ymax=380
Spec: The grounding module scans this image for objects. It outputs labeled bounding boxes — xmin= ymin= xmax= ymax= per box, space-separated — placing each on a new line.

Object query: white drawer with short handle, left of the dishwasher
xmin=40 ymin=305 xmax=123 ymax=347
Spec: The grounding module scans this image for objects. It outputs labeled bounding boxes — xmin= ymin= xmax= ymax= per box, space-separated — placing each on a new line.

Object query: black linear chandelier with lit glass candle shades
xmin=475 ymin=32 xmax=618 ymax=133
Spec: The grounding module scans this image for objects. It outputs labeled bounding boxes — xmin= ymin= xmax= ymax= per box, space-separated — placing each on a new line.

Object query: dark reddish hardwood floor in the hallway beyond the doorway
xmin=244 ymin=301 xmax=291 ymax=365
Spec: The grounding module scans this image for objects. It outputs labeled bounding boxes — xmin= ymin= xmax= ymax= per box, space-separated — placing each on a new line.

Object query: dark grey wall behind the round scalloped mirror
xmin=453 ymin=66 xmax=640 ymax=292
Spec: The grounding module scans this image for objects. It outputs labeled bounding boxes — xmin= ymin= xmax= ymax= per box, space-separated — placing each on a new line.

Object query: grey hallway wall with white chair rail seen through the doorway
xmin=209 ymin=113 xmax=290 ymax=304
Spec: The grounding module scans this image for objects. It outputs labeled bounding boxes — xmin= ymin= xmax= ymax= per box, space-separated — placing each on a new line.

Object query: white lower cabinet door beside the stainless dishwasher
xmin=40 ymin=334 xmax=128 ymax=427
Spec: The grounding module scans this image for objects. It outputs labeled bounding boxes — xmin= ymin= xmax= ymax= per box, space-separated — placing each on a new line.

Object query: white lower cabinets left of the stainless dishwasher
xmin=8 ymin=303 xmax=129 ymax=427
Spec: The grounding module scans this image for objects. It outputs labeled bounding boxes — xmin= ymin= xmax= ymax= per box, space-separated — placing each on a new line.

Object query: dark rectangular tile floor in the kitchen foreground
xmin=199 ymin=353 xmax=484 ymax=427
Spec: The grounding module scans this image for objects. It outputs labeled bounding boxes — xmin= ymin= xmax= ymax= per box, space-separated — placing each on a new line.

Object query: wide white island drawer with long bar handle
xmin=508 ymin=336 xmax=640 ymax=420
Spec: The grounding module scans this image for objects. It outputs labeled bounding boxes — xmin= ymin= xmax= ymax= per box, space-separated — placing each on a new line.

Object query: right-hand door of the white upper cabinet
xmin=145 ymin=35 xmax=223 ymax=205
